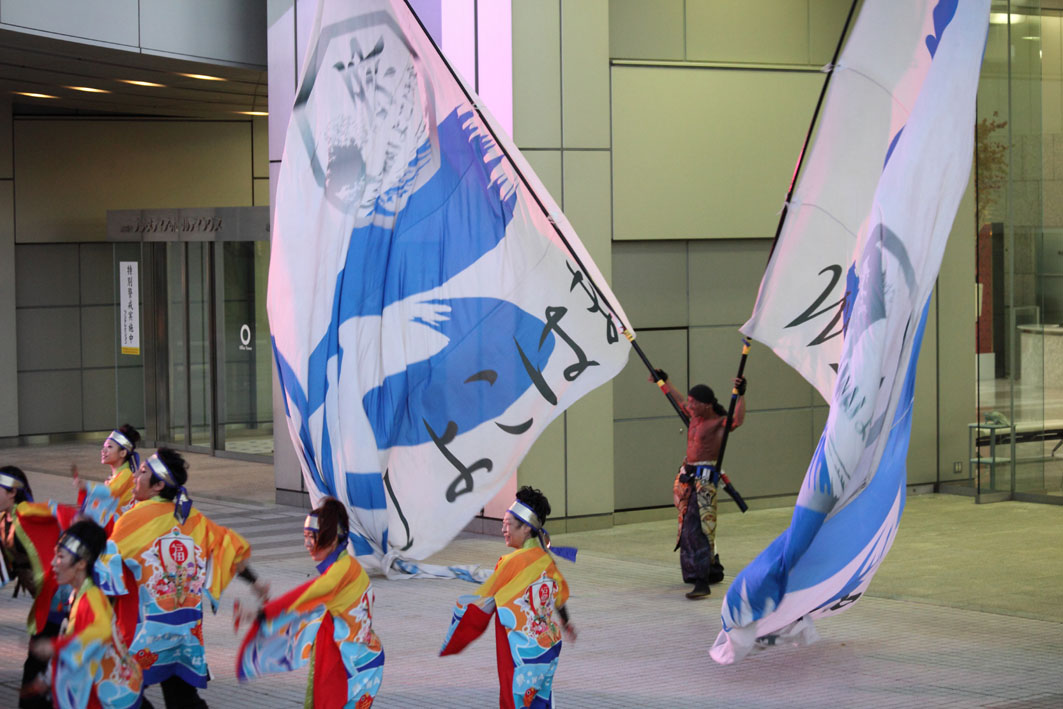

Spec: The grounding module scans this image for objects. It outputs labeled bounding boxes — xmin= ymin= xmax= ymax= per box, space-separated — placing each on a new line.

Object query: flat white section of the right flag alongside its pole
xmin=741 ymin=0 xmax=956 ymax=403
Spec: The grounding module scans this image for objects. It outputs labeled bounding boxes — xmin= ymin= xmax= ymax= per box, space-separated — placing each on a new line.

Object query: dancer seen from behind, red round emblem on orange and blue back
xmin=112 ymin=448 xmax=269 ymax=709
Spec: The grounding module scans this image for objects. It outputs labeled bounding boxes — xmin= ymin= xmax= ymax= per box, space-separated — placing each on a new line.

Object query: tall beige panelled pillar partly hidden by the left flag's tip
xmin=512 ymin=0 xmax=614 ymax=520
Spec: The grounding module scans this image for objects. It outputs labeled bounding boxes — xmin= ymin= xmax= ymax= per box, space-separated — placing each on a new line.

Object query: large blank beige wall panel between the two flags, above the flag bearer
xmin=612 ymin=66 xmax=823 ymax=244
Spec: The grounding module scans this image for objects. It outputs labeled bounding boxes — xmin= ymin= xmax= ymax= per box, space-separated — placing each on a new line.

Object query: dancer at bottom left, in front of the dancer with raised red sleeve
xmin=24 ymin=520 xmax=140 ymax=709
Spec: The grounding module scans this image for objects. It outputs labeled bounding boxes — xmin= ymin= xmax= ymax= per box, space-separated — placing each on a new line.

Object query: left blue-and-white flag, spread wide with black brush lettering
xmin=268 ymin=0 xmax=630 ymax=575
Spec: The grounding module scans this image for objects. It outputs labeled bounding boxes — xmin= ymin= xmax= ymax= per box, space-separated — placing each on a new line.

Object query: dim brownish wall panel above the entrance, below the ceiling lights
xmin=15 ymin=119 xmax=254 ymax=243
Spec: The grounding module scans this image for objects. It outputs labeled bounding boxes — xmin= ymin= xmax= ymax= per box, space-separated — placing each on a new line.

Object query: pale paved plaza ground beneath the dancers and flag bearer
xmin=0 ymin=467 xmax=1063 ymax=709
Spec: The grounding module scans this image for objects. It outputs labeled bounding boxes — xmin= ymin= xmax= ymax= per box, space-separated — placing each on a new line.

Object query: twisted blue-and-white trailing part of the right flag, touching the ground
xmin=711 ymin=0 xmax=990 ymax=663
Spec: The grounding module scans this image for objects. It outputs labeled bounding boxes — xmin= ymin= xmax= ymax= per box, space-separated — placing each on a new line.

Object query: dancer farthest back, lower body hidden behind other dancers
xmin=71 ymin=423 xmax=140 ymax=535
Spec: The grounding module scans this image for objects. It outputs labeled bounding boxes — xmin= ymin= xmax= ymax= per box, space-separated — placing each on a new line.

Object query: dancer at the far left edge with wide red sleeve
xmin=0 ymin=466 xmax=77 ymax=709
